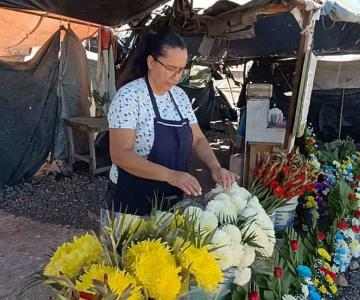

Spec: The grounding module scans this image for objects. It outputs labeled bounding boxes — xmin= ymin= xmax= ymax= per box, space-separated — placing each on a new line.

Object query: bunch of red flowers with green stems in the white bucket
xmin=251 ymin=150 xmax=318 ymax=214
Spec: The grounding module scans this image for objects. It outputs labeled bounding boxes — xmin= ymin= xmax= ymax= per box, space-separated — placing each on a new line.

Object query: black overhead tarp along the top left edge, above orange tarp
xmin=0 ymin=0 xmax=167 ymax=26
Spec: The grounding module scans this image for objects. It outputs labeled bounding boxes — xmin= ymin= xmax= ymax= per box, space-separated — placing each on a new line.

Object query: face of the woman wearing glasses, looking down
xmin=147 ymin=48 xmax=188 ymax=91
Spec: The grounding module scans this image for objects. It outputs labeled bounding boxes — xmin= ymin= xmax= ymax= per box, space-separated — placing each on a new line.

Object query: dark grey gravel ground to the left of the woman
xmin=0 ymin=174 xmax=108 ymax=229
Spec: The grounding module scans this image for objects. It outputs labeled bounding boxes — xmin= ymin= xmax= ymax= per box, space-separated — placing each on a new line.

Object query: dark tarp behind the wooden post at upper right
xmin=229 ymin=13 xmax=360 ymax=58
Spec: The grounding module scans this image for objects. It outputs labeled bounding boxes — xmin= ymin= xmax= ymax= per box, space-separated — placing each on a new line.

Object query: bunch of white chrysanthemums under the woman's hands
xmin=184 ymin=184 xmax=275 ymax=286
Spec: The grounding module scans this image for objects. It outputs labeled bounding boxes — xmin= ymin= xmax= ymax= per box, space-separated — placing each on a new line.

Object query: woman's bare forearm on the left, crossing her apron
xmin=111 ymin=150 xmax=171 ymax=181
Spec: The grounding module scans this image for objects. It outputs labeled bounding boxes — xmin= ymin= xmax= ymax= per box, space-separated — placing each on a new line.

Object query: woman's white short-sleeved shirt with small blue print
xmin=108 ymin=78 xmax=197 ymax=183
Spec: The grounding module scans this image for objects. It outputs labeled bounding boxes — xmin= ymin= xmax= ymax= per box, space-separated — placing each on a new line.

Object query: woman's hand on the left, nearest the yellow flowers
xmin=167 ymin=170 xmax=202 ymax=196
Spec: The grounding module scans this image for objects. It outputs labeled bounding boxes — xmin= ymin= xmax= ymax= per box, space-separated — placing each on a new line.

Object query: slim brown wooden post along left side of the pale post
xmin=284 ymin=11 xmax=313 ymax=151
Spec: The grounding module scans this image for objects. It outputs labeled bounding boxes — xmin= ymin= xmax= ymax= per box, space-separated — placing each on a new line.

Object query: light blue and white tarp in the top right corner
xmin=322 ymin=0 xmax=360 ymax=23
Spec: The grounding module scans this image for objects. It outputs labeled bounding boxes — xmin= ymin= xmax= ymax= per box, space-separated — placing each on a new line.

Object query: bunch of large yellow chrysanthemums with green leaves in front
xmin=37 ymin=209 xmax=222 ymax=300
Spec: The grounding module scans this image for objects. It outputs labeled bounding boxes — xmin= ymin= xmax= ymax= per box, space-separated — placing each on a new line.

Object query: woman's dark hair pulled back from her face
xmin=118 ymin=31 xmax=186 ymax=87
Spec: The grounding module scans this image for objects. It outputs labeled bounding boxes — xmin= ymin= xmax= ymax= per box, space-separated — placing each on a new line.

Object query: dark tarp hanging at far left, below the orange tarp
xmin=0 ymin=32 xmax=60 ymax=185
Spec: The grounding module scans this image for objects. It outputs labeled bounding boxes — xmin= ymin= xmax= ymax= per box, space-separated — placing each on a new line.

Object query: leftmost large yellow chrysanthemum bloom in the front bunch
xmin=44 ymin=233 xmax=103 ymax=278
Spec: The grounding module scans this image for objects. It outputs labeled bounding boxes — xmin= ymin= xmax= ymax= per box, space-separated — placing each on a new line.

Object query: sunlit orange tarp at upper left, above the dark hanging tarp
xmin=0 ymin=8 xmax=98 ymax=58
